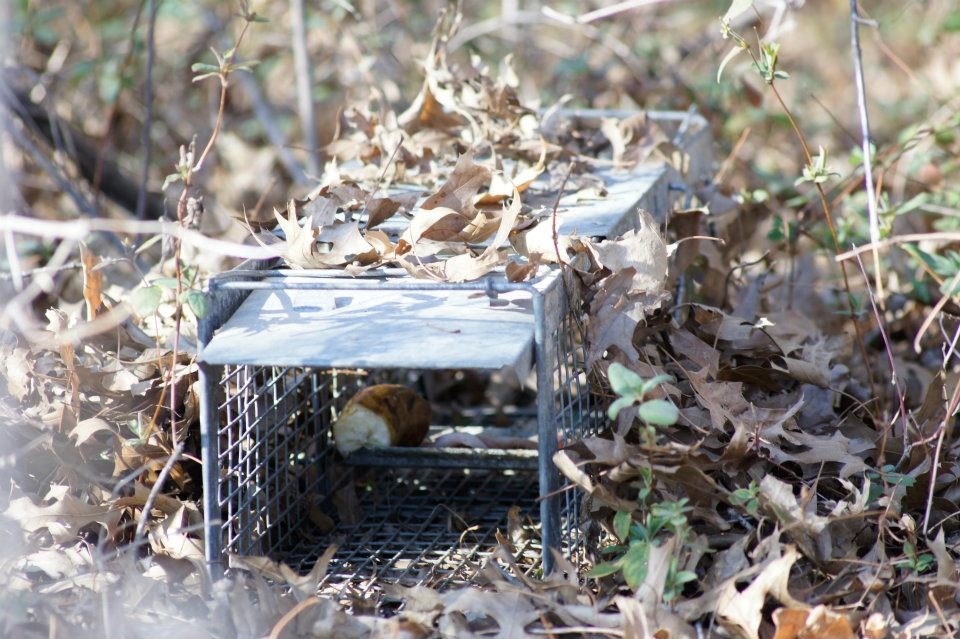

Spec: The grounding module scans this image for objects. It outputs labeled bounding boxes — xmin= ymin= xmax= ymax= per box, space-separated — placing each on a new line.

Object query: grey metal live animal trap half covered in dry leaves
xmin=199 ymin=113 xmax=710 ymax=592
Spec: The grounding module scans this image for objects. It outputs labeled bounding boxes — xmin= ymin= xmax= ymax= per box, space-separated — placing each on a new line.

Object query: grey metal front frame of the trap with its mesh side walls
xmin=200 ymin=270 xmax=602 ymax=584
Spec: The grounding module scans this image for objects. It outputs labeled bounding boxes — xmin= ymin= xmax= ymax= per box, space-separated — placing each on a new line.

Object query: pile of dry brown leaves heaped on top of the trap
xmin=251 ymin=8 xmax=668 ymax=282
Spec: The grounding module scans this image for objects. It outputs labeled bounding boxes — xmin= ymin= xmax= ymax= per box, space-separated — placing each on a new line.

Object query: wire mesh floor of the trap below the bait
xmin=281 ymin=468 xmax=541 ymax=596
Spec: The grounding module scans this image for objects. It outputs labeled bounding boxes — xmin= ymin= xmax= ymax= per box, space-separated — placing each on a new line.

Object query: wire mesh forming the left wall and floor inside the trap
xmin=211 ymin=360 xmax=568 ymax=596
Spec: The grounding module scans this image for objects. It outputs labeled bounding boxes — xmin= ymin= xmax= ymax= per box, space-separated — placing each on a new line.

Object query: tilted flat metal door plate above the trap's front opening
xmin=201 ymin=271 xmax=560 ymax=379
